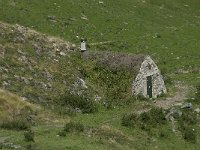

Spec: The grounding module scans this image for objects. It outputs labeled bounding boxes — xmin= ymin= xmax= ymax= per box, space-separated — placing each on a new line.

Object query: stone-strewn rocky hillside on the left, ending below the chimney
xmin=0 ymin=23 xmax=83 ymax=107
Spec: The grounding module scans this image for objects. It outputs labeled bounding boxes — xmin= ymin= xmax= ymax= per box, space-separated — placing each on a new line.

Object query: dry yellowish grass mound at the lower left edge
xmin=0 ymin=90 xmax=38 ymax=130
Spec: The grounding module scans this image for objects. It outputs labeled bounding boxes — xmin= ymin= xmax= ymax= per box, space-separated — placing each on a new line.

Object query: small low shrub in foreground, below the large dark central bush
xmin=64 ymin=122 xmax=84 ymax=132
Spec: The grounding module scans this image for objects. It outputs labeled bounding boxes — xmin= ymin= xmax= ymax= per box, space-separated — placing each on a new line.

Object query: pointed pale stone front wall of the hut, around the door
xmin=132 ymin=56 xmax=167 ymax=98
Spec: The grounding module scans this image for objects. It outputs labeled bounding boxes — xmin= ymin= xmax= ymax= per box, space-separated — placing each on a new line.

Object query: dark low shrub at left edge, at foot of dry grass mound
xmin=1 ymin=119 xmax=30 ymax=130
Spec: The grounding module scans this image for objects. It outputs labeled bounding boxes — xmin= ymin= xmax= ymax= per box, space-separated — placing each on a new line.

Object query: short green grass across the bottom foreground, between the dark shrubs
xmin=0 ymin=103 xmax=200 ymax=150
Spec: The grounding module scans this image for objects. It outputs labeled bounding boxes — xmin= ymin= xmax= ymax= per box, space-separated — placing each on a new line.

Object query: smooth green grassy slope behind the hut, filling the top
xmin=0 ymin=0 xmax=200 ymax=84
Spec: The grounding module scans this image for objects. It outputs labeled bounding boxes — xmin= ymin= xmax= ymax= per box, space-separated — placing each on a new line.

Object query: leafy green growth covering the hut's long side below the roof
xmin=82 ymin=61 xmax=135 ymax=108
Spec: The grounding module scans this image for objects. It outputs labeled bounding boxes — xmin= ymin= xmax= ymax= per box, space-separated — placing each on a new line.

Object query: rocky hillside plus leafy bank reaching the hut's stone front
xmin=0 ymin=22 xmax=147 ymax=109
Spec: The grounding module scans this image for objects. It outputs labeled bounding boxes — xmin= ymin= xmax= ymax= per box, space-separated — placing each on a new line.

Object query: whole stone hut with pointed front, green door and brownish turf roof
xmin=82 ymin=51 xmax=167 ymax=98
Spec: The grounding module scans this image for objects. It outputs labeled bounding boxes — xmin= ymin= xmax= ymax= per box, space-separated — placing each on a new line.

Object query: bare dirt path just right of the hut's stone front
xmin=154 ymin=84 xmax=190 ymax=109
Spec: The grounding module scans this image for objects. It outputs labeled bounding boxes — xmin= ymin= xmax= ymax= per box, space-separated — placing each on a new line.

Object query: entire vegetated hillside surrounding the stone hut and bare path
xmin=0 ymin=0 xmax=200 ymax=150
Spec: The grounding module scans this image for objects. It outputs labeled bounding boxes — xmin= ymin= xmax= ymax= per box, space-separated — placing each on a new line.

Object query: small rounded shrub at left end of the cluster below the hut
xmin=122 ymin=114 xmax=137 ymax=127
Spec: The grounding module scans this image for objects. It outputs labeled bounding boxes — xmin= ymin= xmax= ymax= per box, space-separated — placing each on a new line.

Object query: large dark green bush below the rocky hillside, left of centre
xmin=61 ymin=92 xmax=98 ymax=113
